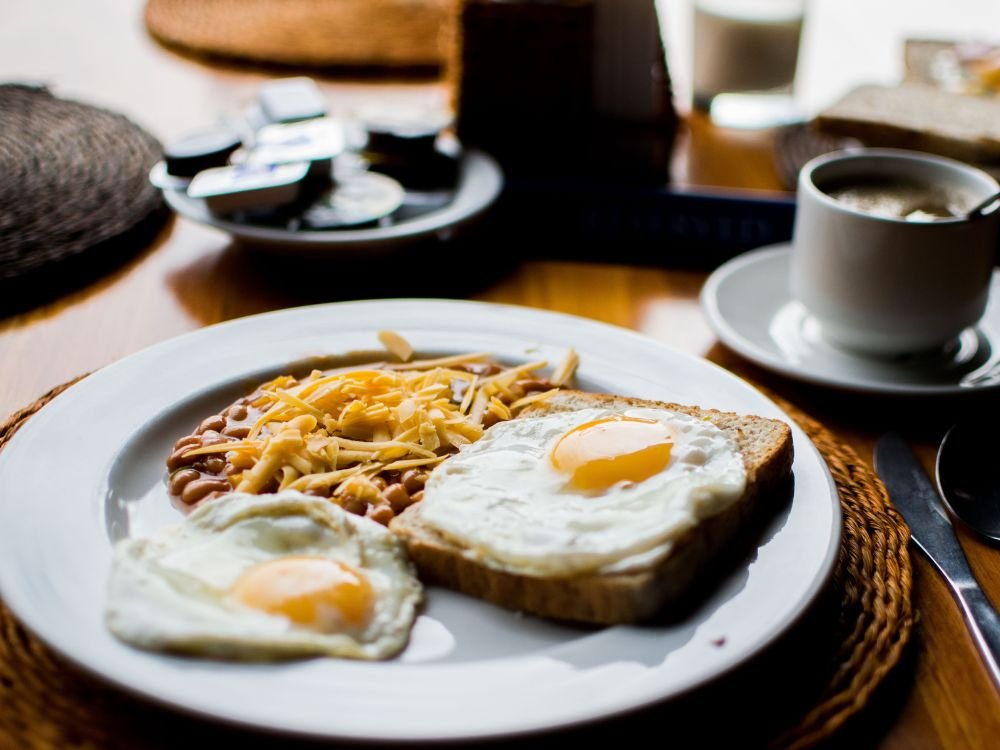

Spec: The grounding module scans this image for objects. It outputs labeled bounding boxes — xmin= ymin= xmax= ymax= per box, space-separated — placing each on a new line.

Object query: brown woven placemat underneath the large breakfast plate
xmin=0 ymin=378 xmax=913 ymax=750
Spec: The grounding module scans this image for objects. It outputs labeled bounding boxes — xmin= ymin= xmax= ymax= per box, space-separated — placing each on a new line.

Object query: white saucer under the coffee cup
xmin=701 ymin=244 xmax=1000 ymax=395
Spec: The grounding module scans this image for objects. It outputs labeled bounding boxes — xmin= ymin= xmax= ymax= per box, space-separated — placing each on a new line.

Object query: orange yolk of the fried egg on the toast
xmin=551 ymin=417 xmax=673 ymax=490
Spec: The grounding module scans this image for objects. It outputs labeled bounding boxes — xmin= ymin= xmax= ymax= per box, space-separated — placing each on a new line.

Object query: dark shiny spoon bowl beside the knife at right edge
xmin=937 ymin=422 xmax=1000 ymax=542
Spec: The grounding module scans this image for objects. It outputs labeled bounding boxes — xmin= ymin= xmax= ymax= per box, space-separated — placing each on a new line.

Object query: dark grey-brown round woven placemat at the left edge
xmin=0 ymin=84 xmax=168 ymax=312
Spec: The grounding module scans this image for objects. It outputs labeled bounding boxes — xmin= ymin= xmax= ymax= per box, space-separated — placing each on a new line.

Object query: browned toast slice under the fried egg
xmin=389 ymin=391 xmax=792 ymax=625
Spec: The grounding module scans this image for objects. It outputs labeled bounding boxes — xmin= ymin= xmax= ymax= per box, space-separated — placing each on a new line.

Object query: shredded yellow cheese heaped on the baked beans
xmin=184 ymin=340 xmax=577 ymax=502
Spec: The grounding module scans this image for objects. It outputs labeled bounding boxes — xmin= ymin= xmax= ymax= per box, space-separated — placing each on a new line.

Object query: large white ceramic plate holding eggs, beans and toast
xmin=0 ymin=300 xmax=840 ymax=740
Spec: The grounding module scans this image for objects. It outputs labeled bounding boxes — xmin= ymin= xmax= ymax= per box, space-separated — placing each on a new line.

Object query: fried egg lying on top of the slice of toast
xmin=419 ymin=407 xmax=746 ymax=576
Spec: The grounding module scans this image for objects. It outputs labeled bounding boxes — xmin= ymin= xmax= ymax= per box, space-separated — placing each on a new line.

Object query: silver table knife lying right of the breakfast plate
xmin=875 ymin=434 xmax=1000 ymax=688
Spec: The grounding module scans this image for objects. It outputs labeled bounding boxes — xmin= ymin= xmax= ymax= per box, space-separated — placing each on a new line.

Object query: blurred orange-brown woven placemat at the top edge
xmin=146 ymin=0 xmax=455 ymax=68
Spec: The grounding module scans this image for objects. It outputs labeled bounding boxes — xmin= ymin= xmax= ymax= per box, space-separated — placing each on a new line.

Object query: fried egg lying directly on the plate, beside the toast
xmin=106 ymin=491 xmax=421 ymax=659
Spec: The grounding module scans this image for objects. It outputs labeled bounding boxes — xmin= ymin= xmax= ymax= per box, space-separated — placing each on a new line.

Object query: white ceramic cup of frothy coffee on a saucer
xmin=790 ymin=149 xmax=1000 ymax=356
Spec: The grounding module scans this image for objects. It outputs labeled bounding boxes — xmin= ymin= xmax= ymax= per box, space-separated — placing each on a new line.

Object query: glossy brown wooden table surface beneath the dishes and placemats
xmin=0 ymin=0 xmax=1000 ymax=749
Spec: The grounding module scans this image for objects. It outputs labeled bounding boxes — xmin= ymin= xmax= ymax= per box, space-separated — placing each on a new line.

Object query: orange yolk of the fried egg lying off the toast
xmin=232 ymin=557 xmax=374 ymax=633
